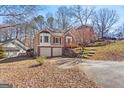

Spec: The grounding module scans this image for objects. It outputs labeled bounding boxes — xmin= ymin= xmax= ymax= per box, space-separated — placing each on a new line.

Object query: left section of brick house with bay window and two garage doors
xmin=34 ymin=29 xmax=64 ymax=57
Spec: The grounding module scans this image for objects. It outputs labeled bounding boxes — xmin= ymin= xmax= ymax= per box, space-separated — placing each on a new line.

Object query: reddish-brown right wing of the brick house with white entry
xmin=64 ymin=25 xmax=97 ymax=48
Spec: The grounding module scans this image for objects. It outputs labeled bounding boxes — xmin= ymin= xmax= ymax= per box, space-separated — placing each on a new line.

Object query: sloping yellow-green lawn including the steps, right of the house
xmin=74 ymin=40 xmax=124 ymax=61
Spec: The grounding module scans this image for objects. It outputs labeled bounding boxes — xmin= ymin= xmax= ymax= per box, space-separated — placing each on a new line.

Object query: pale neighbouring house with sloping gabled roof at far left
xmin=0 ymin=39 xmax=28 ymax=58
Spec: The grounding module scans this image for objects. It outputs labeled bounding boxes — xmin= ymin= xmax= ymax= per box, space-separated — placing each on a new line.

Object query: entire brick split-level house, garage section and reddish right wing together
xmin=34 ymin=26 xmax=96 ymax=57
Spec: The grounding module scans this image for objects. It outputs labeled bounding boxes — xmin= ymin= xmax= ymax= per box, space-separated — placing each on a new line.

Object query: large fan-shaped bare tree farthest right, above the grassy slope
xmin=92 ymin=8 xmax=119 ymax=39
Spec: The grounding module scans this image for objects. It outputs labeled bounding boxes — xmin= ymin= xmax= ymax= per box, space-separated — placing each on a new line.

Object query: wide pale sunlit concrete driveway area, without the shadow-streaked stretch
xmin=79 ymin=61 xmax=124 ymax=88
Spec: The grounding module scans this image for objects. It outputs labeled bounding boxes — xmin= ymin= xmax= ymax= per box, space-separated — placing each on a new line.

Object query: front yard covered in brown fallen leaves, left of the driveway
xmin=0 ymin=59 xmax=97 ymax=88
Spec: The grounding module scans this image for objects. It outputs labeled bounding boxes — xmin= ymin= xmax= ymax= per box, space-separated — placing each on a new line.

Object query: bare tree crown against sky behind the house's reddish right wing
xmin=69 ymin=5 xmax=95 ymax=25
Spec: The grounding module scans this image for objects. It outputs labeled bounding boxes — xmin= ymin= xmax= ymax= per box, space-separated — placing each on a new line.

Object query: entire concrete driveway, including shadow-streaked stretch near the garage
xmin=54 ymin=58 xmax=124 ymax=88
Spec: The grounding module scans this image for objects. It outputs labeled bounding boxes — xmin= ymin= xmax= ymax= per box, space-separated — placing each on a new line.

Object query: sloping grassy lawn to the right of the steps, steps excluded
xmin=86 ymin=41 xmax=124 ymax=61
